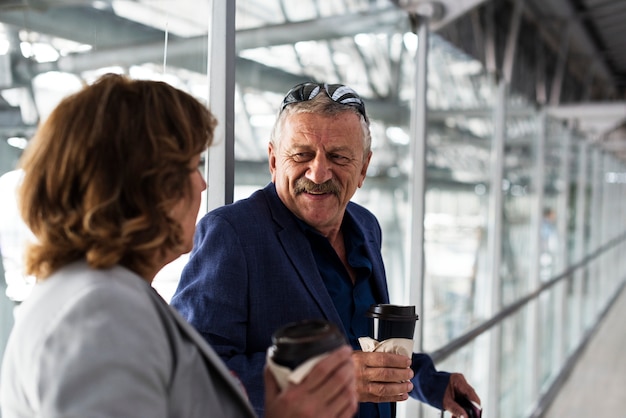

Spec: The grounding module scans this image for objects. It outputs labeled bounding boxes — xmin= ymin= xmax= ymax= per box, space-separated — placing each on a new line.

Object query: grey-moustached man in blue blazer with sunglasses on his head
xmin=172 ymin=83 xmax=480 ymax=418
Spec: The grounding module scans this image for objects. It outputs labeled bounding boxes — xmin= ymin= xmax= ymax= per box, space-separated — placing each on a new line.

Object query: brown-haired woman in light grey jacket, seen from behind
xmin=0 ymin=75 xmax=356 ymax=418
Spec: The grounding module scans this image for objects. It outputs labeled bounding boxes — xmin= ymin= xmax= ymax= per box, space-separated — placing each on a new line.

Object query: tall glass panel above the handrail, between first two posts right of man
xmin=422 ymin=36 xmax=495 ymax=350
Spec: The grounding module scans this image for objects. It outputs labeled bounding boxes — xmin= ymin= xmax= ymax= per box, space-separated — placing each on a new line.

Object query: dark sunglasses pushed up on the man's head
xmin=280 ymin=82 xmax=367 ymax=122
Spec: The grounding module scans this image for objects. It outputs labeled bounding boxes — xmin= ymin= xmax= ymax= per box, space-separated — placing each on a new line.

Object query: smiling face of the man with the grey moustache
xmin=269 ymin=111 xmax=371 ymax=236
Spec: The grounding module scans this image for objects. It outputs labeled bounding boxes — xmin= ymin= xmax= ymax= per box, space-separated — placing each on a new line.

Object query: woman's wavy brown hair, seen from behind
xmin=20 ymin=74 xmax=216 ymax=278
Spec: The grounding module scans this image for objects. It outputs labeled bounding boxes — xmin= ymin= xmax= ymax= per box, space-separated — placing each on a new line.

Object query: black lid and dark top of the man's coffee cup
xmin=366 ymin=304 xmax=419 ymax=341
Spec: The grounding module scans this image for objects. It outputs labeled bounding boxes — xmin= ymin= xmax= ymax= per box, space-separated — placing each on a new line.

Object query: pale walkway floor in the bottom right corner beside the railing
xmin=544 ymin=289 xmax=626 ymax=418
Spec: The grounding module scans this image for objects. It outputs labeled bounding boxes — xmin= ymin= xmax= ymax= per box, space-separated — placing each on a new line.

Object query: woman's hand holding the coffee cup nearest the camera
xmin=264 ymin=346 xmax=358 ymax=418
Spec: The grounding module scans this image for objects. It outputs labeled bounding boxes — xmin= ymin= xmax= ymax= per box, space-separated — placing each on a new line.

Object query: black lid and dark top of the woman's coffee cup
xmin=269 ymin=320 xmax=347 ymax=370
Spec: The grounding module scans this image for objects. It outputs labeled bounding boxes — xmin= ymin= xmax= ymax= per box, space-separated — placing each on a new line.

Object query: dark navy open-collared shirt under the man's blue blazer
xmin=299 ymin=213 xmax=391 ymax=418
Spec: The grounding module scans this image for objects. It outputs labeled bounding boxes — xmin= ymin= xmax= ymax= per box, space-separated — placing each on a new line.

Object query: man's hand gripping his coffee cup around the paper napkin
xmin=352 ymin=351 xmax=413 ymax=402
